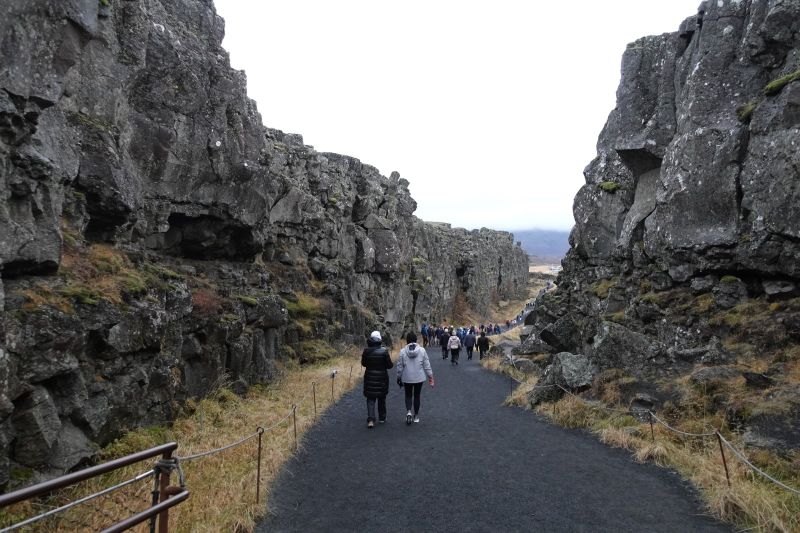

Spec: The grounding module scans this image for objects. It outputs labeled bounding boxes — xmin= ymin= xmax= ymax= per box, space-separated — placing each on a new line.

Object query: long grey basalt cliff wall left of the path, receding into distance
xmin=0 ymin=0 xmax=527 ymax=485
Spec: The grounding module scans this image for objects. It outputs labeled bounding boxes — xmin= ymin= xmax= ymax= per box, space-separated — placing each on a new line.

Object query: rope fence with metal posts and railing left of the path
xmin=0 ymin=365 xmax=346 ymax=533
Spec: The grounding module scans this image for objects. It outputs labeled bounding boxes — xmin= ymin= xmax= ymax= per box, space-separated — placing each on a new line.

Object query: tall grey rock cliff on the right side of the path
xmin=522 ymin=0 xmax=800 ymax=444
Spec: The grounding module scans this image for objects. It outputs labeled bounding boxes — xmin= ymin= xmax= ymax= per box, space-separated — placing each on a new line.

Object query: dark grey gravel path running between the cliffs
xmin=257 ymin=348 xmax=730 ymax=533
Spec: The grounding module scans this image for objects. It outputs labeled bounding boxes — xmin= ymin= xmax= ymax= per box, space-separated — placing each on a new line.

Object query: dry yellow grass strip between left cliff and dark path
xmin=0 ymin=350 xmax=361 ymax=532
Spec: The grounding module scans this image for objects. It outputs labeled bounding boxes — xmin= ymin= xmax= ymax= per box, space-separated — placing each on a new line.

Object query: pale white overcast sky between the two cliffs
xmin=215 ymin=0 xmax=699 ymax=230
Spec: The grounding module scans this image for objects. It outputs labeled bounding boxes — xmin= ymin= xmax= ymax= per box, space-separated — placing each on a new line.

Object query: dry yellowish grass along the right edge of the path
xmin=483 ymin=358 xmax=800 ymax=533
